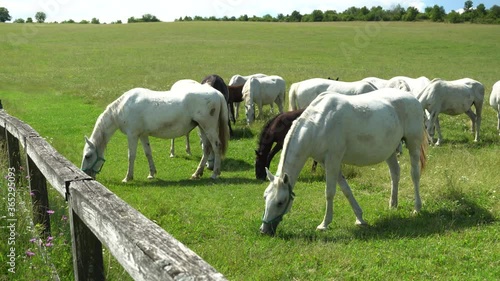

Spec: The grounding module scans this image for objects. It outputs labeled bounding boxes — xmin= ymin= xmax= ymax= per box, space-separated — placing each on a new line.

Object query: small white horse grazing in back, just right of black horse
xmin=242 ymin=75 xmax=286 ymax=124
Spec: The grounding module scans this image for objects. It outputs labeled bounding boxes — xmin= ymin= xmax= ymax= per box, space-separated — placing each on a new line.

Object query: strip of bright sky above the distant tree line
xmin=0 ymin=0 xmax=500 ymax=23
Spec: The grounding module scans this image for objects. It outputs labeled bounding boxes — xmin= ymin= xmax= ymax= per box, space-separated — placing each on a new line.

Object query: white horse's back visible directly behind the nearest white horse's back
xmin=288 ymin=78 xmax=377 ymax=110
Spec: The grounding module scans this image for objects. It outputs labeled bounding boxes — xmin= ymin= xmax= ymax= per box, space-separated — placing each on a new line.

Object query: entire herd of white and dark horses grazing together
xmin=81 ymin=73 xmax=500 ymax=235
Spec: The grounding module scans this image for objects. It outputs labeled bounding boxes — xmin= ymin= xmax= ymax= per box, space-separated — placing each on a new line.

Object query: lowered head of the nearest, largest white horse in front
xmin=260 ymin=168 xmax=295 ymax=236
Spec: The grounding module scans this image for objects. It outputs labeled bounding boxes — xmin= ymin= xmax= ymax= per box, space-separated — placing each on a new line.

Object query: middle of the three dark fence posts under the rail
xmin=26 ymin=152 xmax=50 ymax=237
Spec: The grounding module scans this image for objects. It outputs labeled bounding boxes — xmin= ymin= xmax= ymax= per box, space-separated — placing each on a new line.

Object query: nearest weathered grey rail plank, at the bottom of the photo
xmin=69 ymin=181 xmax=226 ymax=280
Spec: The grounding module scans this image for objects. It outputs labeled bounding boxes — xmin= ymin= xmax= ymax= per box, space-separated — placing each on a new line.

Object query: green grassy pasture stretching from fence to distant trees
xmin=0 ymin=22 xmax=500 ymax=280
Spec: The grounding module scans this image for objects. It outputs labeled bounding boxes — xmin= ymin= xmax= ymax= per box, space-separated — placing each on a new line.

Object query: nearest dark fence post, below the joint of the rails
xmin=66 ymin=180 xmax=105 ymax=281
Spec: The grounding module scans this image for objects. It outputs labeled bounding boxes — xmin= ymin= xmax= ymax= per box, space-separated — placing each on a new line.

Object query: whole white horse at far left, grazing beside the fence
xmin=81 ymin=86 xmax=229 ymax=182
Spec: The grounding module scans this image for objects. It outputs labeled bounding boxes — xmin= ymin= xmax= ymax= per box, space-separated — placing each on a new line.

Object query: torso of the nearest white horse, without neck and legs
xmin=308 ymin=88 xmax=423 ymax=166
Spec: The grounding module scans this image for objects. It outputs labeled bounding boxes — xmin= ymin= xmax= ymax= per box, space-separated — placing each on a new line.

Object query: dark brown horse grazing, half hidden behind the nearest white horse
xmin=255 ymin=109 xmax=317 ymax=180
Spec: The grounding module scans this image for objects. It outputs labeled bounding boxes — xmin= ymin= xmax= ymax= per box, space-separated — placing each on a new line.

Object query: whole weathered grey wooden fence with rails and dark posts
xmin=0 ymin=101 xmax=226 ymax=281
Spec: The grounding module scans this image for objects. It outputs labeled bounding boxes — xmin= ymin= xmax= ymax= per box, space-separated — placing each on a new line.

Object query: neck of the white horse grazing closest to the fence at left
xmin=90 ymin=107 xmax=118 ymax=156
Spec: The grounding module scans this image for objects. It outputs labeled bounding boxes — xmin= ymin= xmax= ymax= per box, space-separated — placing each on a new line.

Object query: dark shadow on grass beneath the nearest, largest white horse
xmin=278 ymin=191 xmax=497 ymax=242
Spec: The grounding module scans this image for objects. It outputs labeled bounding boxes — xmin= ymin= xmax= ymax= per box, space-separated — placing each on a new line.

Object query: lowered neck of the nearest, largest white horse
xmin=276 ymin=120 xmax=312 ymax=187
